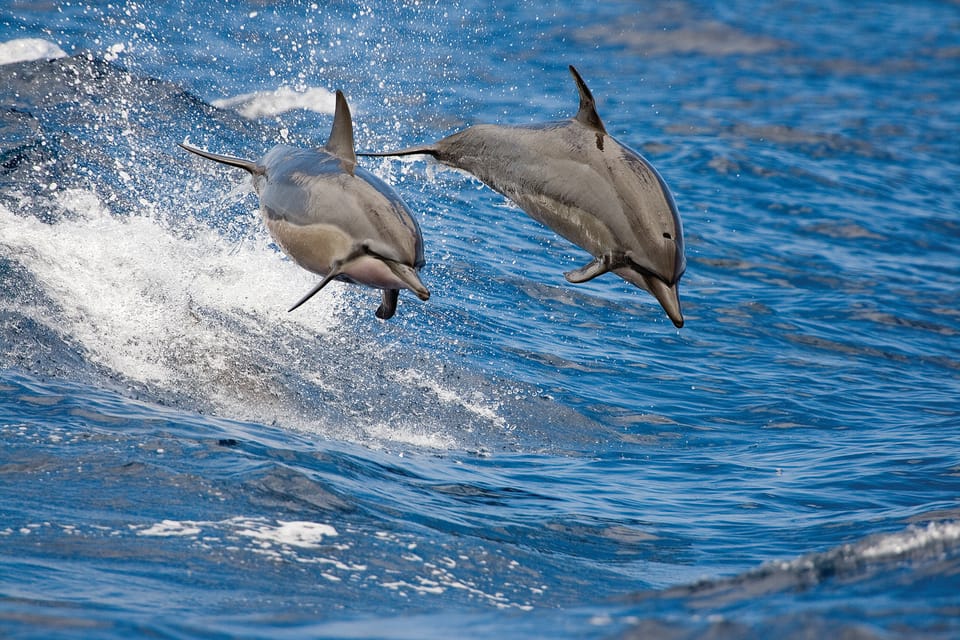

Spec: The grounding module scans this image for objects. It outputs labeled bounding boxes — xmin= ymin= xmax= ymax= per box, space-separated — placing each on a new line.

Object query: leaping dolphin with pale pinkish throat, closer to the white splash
xmin=180 ymin=91 xmax=430 ymax=320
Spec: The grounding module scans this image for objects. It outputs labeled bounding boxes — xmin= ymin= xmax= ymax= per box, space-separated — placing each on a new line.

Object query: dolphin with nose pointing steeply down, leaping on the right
xmin=359 ymin=66 xmax=687 ymax=328
